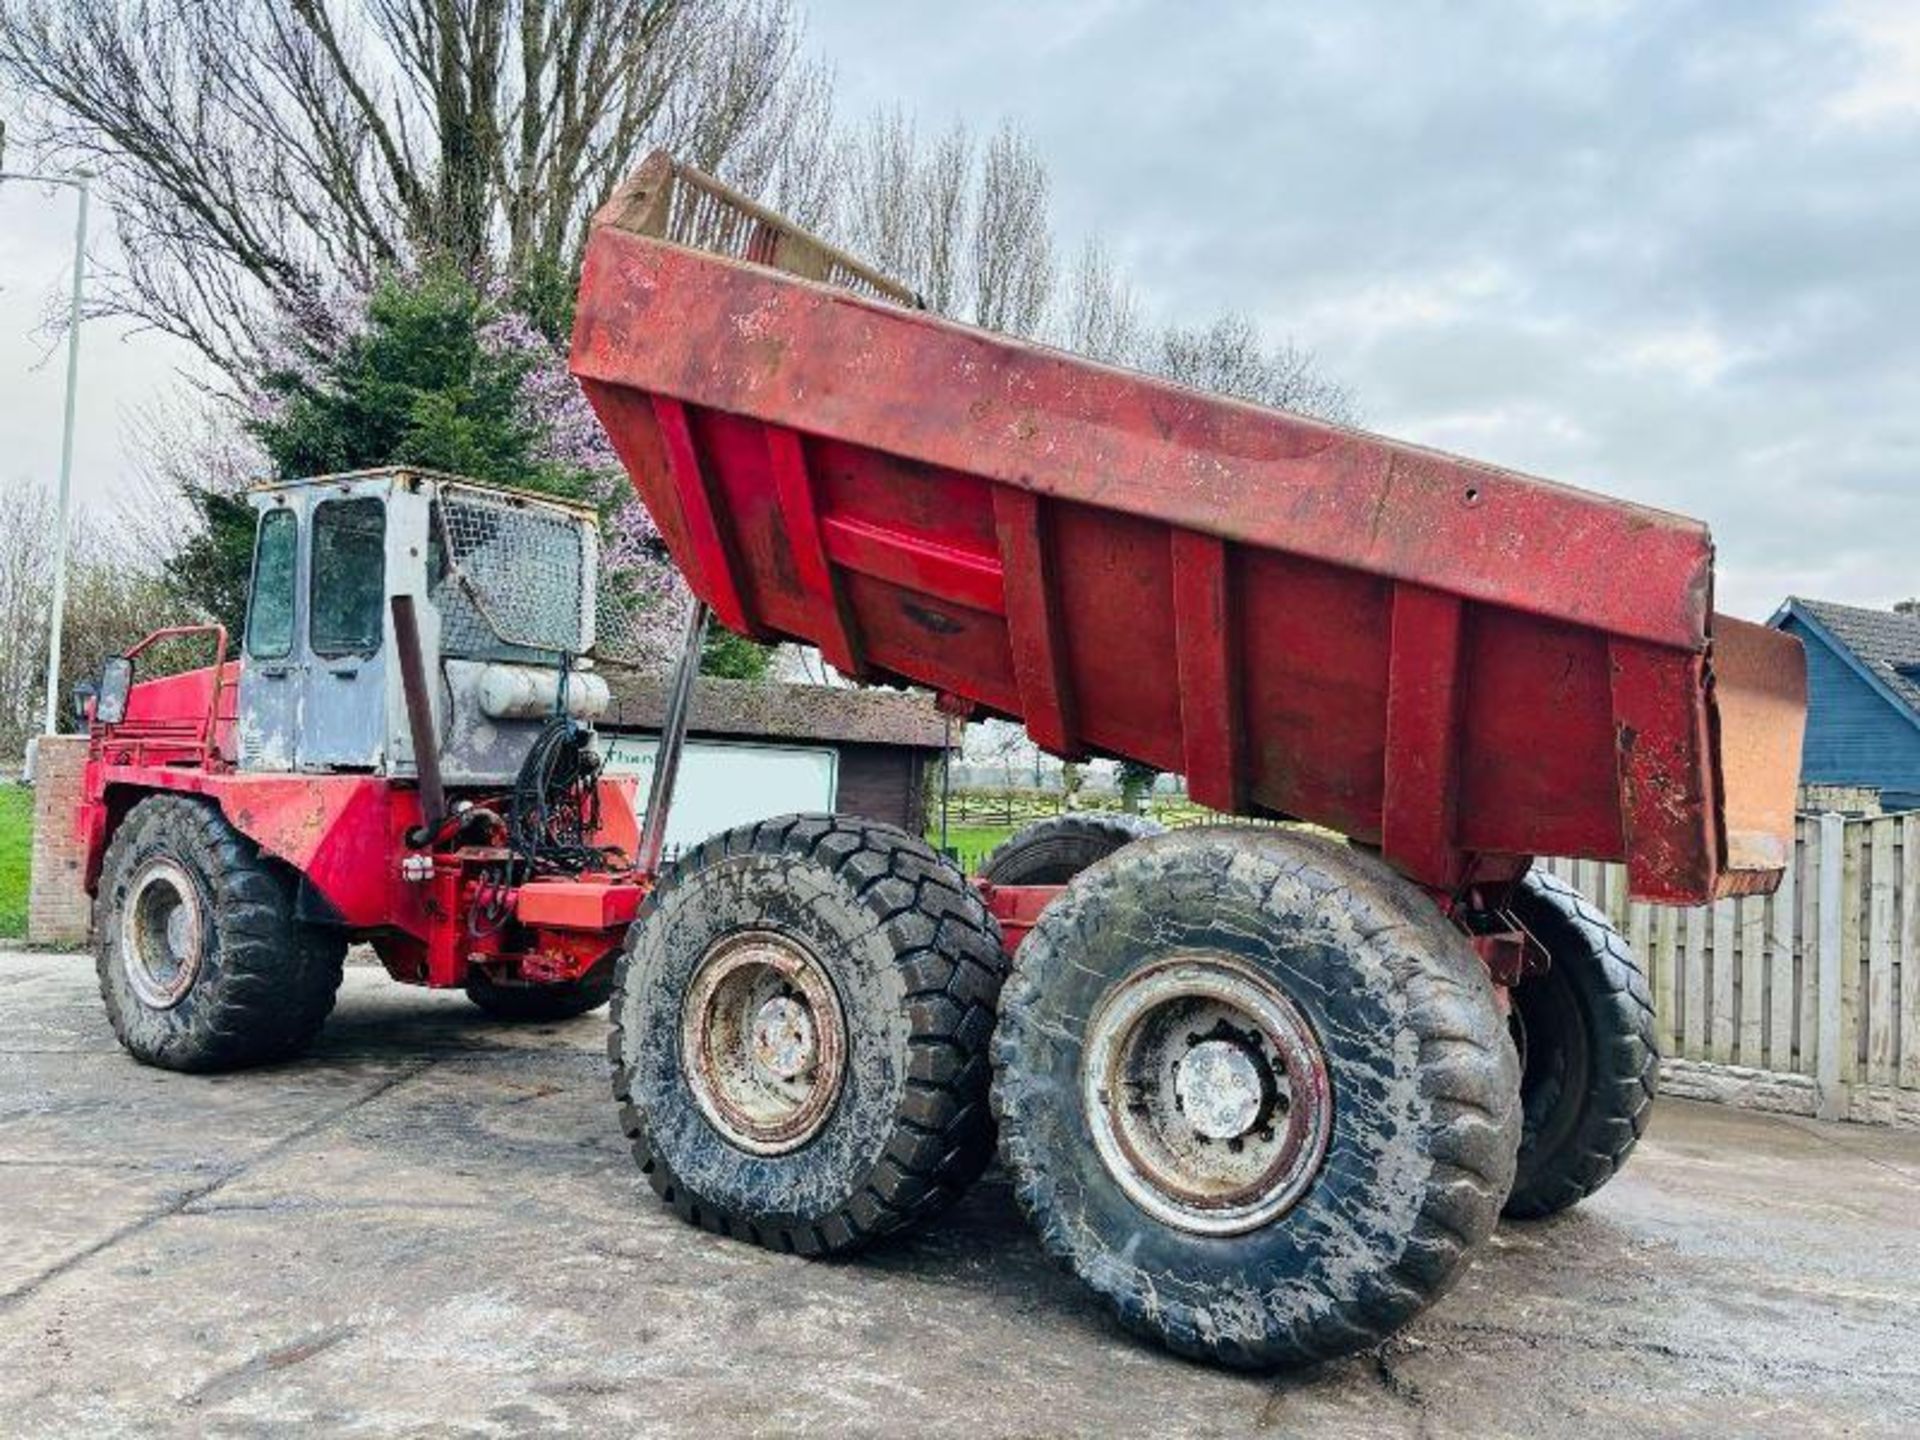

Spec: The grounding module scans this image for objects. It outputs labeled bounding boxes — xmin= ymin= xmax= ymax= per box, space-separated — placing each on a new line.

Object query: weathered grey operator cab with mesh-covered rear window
xmin=236 ymin=470 xmax=609 ymax=785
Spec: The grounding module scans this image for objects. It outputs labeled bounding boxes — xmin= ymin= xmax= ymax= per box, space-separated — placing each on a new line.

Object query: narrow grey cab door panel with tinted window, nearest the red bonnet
xmin=238 ymin=503 xmax=303 ymax=770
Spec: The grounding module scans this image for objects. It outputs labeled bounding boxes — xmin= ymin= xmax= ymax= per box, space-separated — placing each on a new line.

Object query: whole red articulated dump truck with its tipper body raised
xmin=81 ymin=156 xmax=1805 ymax=1367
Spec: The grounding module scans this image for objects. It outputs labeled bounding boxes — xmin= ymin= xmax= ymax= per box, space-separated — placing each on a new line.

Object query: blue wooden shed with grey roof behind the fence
xmin=1768 ymin=595 xmax=1920 ymax=810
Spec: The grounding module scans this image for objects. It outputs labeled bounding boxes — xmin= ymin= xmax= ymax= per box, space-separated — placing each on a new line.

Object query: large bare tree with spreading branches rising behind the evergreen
xmin=0 ymin=0 xmax=831 ymax=363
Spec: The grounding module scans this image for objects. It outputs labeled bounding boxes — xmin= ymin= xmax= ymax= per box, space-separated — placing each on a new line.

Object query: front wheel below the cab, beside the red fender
xmin=94 ymin=795 xmax=346 ymax=1071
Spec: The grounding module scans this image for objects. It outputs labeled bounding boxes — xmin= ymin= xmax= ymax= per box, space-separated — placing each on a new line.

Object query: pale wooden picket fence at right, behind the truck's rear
xmin=1549 ymin=814 xmax=1920 ymax=1125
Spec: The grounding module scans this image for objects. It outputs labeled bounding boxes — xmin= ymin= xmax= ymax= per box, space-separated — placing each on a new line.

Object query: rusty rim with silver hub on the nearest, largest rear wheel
xmin=1081 ymin=956 xmax=1332 ymax=1235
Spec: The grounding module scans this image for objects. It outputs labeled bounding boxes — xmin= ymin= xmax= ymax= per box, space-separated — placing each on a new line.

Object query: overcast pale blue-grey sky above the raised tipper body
xmin=0 ymin=0 xmax=1920 ymax=616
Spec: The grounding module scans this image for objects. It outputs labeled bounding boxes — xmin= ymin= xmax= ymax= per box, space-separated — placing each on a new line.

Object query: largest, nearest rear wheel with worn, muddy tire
xmin=993 ymin=829 xmax=1519 ymax=1367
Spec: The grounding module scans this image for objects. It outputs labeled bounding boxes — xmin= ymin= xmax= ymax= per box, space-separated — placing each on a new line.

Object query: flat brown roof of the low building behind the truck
xmin=601 ymin=672 xmax=947 ymax=751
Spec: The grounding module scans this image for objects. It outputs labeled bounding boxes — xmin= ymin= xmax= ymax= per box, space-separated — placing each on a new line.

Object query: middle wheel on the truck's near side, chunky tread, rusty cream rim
xmin=609 ymin=816 xmax=1006 ymax=1254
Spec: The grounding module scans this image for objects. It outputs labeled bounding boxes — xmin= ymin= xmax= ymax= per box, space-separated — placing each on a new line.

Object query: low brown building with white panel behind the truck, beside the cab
xmin=597 ymin=674 xmax=948 ymax=845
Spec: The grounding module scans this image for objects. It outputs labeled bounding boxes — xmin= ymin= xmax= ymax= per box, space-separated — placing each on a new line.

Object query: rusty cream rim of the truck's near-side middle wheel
xmin=680 ymin=931 xmax=847 ymax=1156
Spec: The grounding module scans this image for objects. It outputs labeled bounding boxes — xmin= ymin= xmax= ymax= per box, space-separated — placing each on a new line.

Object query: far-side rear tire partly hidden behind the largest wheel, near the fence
xmin=1505 ymin=870 xmax=1661 ymax=1219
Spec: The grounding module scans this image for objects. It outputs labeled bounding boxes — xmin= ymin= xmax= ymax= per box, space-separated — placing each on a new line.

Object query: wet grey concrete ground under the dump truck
xmin=0 ymin=954 xmax=1920 ymax=1436
